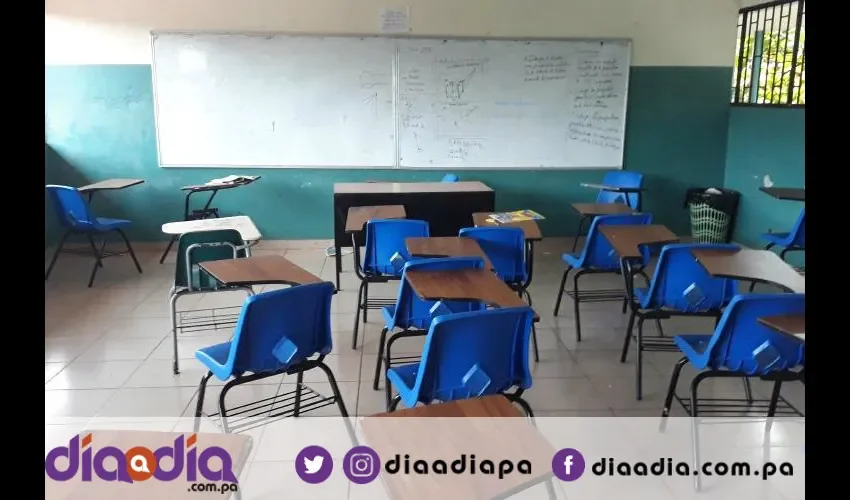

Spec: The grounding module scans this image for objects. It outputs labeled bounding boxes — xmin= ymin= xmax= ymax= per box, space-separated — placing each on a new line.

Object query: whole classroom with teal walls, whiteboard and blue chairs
xmin=45 ymin=0 xmax=806 ymax=500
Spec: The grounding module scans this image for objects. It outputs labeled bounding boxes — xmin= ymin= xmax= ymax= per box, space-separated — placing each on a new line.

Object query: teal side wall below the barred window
xmin=725 ymin=107 xmax=806 ymax=265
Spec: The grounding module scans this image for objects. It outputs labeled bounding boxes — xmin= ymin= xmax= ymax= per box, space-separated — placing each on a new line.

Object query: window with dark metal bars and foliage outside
xmin=732 ymin=0 xmax=806 ymax=106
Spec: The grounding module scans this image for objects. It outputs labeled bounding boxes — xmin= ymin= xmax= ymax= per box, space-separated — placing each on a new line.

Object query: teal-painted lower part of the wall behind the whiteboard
xmin=45 ymin=65 xmax=731 ymax=240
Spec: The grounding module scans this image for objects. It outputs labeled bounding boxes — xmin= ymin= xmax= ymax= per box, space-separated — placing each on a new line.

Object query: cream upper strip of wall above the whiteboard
xmin=45 ymin=0 xmax=747 ymax=66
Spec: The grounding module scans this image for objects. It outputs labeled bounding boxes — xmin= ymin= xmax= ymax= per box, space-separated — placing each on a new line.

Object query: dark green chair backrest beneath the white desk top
xmin=174 ymin=229 xmax=246 ymax=290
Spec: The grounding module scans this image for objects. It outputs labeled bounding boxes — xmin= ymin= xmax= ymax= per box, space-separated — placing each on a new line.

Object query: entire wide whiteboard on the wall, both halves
xmin=152 ymin=33 xmax=631 ymax=169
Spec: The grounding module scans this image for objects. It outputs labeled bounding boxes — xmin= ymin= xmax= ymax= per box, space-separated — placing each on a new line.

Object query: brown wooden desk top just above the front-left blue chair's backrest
xmin=201 ymin=255 xmax=323 ymax=286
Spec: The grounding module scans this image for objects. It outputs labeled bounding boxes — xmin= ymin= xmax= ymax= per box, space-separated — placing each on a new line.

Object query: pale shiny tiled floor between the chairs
xmin=44 ymin=240 xmax=804 ymax=421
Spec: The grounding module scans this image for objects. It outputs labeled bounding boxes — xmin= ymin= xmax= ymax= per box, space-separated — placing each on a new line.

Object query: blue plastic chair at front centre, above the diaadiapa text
xmin=387 ymin=307 xmax=534 ymax=416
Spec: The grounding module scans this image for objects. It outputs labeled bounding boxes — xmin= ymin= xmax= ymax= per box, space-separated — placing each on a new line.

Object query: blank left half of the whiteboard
xmin=151 ymin=33 xmax=396 ymax=167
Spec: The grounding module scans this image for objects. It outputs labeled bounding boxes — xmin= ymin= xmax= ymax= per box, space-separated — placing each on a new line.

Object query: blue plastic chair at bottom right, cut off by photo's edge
xmin=662 ymin=293 xmax=806 ymax=417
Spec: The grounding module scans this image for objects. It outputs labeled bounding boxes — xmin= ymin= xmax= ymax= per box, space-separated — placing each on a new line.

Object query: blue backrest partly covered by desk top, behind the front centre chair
xmin=392 ymin=257 xmax=486 ymax=329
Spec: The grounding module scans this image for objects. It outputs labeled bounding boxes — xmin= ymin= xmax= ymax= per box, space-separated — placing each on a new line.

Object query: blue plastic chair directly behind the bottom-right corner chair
xmin=620 ymin=243 xmax=751 ymax=400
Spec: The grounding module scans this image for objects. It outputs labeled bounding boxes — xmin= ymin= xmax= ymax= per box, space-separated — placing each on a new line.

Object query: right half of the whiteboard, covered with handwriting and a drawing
xmin=397 ymin=40 xmax=631 ymax=168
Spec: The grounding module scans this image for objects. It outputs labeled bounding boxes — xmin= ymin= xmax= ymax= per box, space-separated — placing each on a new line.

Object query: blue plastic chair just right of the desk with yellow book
xmin=555 ymin=214 xmax=652 ymax=342
